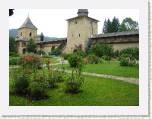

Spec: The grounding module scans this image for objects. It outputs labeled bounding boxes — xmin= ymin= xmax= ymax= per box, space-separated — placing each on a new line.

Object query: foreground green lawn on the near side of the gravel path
xmin=9 ymin=76 xmax=139 ymax=106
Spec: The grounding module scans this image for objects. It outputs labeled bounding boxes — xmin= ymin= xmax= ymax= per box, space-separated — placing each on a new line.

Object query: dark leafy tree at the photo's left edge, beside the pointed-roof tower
xmin=9 ymin=37 xmax=17 ymax=53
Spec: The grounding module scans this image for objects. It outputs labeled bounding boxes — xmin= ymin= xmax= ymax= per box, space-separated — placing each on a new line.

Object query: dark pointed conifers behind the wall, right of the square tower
xmin=103 ymin=17 xmax=120 ymax=33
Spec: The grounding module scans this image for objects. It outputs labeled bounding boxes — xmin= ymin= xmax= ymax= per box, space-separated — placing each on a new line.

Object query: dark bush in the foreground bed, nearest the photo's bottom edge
xmin=29 ymin=80 xmax=48 ymax=100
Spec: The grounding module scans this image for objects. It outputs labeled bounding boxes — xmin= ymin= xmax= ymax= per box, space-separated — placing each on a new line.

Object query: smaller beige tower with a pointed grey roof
xmin=16 ymin=16 xmax=37 ymax=54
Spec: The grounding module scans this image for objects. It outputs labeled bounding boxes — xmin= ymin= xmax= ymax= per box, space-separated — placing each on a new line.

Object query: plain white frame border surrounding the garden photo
xmin=0 ymin=0 xmax=148 ymax=116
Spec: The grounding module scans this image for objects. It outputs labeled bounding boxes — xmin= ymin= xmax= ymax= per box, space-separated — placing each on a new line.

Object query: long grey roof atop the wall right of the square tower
xmin=92 ymin=31 xmax=139 ymax=38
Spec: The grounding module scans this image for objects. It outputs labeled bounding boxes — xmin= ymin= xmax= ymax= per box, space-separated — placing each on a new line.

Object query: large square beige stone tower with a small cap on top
xmin=64 ymin=9 xmax=98 ymax=53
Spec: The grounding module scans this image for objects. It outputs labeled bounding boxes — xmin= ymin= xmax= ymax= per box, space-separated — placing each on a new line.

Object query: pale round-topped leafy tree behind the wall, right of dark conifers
xmin=119 ymin=18 xmax=139 ymax=32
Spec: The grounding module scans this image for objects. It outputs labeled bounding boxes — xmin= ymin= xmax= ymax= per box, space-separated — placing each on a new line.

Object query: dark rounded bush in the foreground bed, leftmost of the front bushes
xmin=13 ymin=75 xmax=29 ymax=95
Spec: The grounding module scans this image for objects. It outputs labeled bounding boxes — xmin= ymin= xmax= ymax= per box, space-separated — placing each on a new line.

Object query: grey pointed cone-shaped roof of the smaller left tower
xmin=19 ymin=16 xmax=37 ymax=30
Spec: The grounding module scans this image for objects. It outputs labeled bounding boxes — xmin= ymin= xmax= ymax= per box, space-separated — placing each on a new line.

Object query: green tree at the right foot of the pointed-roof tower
xmin=26 ymin=39 xmax=36 ymax=53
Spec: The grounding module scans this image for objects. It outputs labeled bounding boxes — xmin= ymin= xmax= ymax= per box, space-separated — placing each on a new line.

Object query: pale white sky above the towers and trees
xmin=9 ymin=9 xmax=139 ymax=38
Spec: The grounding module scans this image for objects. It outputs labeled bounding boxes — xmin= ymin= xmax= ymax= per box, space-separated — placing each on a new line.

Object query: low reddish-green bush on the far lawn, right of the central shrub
xmin=85 ymin=55 xmax=101 ymax=64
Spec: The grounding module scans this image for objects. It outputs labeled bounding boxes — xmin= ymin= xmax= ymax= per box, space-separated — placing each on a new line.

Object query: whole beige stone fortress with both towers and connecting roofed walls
xmin=16 ymin=9 xmax=139 ymax=54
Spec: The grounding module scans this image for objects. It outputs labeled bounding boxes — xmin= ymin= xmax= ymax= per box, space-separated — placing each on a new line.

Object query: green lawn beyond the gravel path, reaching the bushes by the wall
xmin=59 ymin=61 xmax=139 ymax=78
